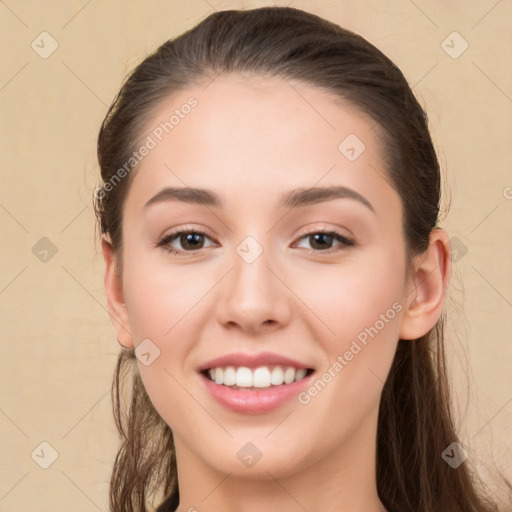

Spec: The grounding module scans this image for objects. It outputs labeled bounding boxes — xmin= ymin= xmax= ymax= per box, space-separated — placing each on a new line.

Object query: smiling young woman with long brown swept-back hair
xmin=96 ymin=7 xmax=506 ymax=512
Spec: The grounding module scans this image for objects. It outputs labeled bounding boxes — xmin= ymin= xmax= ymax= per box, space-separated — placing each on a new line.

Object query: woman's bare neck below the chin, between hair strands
xmin=175 ymin=412 xmax=385 ymax=512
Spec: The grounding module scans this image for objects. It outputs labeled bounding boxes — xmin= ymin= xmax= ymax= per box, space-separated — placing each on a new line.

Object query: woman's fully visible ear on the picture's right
xmin=400 ymin=228 xmax=452 ymax=340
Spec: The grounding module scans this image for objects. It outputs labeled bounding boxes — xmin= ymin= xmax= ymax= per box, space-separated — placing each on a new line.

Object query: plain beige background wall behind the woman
xmin=0 ymin=0 xmax=512 ymax=512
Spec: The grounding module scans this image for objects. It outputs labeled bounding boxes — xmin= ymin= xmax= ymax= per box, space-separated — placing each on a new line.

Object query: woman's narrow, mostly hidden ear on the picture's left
xmin=101 ymin=234 xmax=134 ymax=348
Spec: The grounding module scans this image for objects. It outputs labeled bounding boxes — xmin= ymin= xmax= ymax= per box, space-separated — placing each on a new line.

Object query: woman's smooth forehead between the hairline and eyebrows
xmin=122 ymin=75 xmax=396 ymax=216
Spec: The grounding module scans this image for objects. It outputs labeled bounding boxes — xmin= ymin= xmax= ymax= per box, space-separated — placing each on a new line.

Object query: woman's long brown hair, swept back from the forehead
xmin=95 ymin=7 xmax=508 ymax=512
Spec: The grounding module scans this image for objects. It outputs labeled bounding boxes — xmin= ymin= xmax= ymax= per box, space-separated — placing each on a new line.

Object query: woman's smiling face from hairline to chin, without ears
xmin=106 ymin=75 xmax=418 ymax=478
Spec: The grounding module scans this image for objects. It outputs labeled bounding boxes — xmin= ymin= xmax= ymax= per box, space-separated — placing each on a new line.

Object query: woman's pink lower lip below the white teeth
xmin=200 ymin=372 xmax=315 ymax=414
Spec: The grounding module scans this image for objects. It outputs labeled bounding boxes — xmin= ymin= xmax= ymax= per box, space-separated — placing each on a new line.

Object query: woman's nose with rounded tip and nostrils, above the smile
xmin=216 ymin=241 xmax=293 ymax=333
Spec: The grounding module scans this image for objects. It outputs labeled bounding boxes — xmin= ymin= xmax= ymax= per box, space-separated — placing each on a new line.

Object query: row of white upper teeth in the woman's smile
xmin=208 ymin=366 xmax=307 ymax=388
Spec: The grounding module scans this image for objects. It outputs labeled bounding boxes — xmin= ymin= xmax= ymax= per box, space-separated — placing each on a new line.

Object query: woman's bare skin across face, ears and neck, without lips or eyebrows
xmin=102 ymin=75 xmax=450 ymax=512
